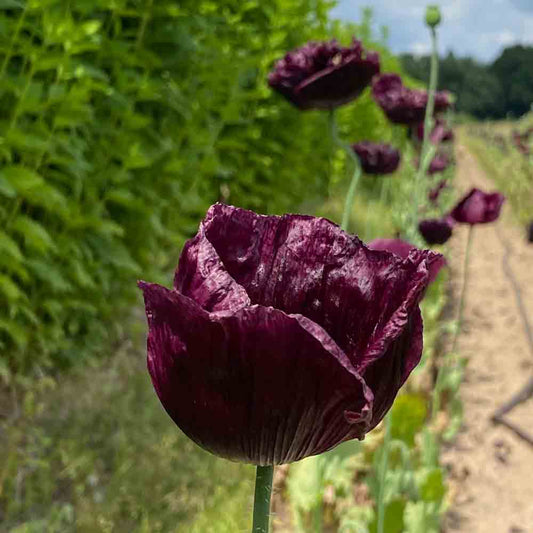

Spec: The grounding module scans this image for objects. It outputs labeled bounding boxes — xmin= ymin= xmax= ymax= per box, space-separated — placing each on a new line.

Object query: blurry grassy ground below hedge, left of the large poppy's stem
xmin=0 ymin=339 xmax=254 ymax=533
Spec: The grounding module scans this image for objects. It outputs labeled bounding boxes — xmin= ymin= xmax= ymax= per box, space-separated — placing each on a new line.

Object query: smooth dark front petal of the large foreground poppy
xmin=140 ymin=282 xmax=372 ymax=465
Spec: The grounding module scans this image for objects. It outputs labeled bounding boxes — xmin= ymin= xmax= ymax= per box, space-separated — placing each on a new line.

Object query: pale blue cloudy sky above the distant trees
xmin=332 ymin=0 xmax=533 ymax=61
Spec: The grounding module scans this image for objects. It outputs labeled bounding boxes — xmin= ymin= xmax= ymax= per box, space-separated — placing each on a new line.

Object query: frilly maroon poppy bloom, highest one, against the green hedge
xmin=268 ymin=39 xmax=379 ymax=109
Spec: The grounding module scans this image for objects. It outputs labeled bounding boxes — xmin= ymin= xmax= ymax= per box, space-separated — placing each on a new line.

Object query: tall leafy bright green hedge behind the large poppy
xmin=0 ymin=0 xmax=406 ymax=373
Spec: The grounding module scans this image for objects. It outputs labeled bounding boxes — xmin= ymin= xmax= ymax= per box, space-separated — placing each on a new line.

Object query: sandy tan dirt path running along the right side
xmin=442 ymin=143 xmax=533 ymax=533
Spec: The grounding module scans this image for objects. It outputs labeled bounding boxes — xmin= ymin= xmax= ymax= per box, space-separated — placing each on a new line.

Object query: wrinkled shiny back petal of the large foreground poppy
xmin=203 ymin=204 xmax=440 ymax=390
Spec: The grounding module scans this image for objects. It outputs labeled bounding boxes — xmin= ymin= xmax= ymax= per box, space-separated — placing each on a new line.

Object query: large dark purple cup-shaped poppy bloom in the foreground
xmin=139 ymin=204 xmax=440 ymax=465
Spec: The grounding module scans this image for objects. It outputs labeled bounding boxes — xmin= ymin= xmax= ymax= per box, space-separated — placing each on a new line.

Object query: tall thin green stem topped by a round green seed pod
xmin=412 ymin=24 xmax=439 ymax=234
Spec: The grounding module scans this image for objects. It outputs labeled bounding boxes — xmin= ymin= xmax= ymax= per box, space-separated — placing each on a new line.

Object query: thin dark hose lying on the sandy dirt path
xmin=491 ymin=225 xmax=533 ymax=446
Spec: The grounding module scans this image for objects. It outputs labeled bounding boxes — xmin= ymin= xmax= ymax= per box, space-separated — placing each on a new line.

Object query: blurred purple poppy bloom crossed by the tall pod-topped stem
xmin=372 ymin=74 xmax=451 ymax=126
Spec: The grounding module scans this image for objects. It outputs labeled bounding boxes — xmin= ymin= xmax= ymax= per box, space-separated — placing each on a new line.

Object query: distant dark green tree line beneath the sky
xmin=401 ymin=45 xmax=533 ymax=119
